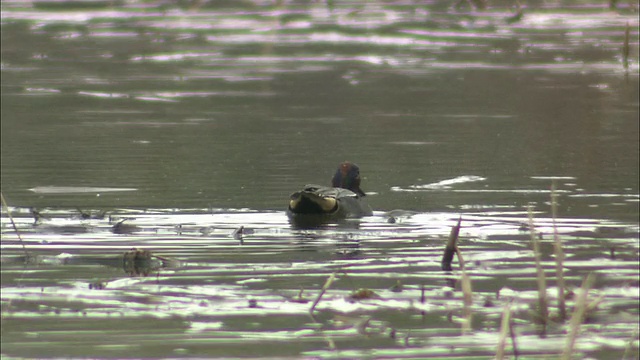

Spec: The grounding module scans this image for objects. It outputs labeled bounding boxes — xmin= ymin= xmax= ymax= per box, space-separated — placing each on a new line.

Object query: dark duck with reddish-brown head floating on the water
xmin=287 ymin=161 xmax=373 ymax=219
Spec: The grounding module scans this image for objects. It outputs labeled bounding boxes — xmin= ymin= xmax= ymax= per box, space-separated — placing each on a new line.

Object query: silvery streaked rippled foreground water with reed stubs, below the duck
xmin=2 ymin=204 xmax=640 ymax=358
